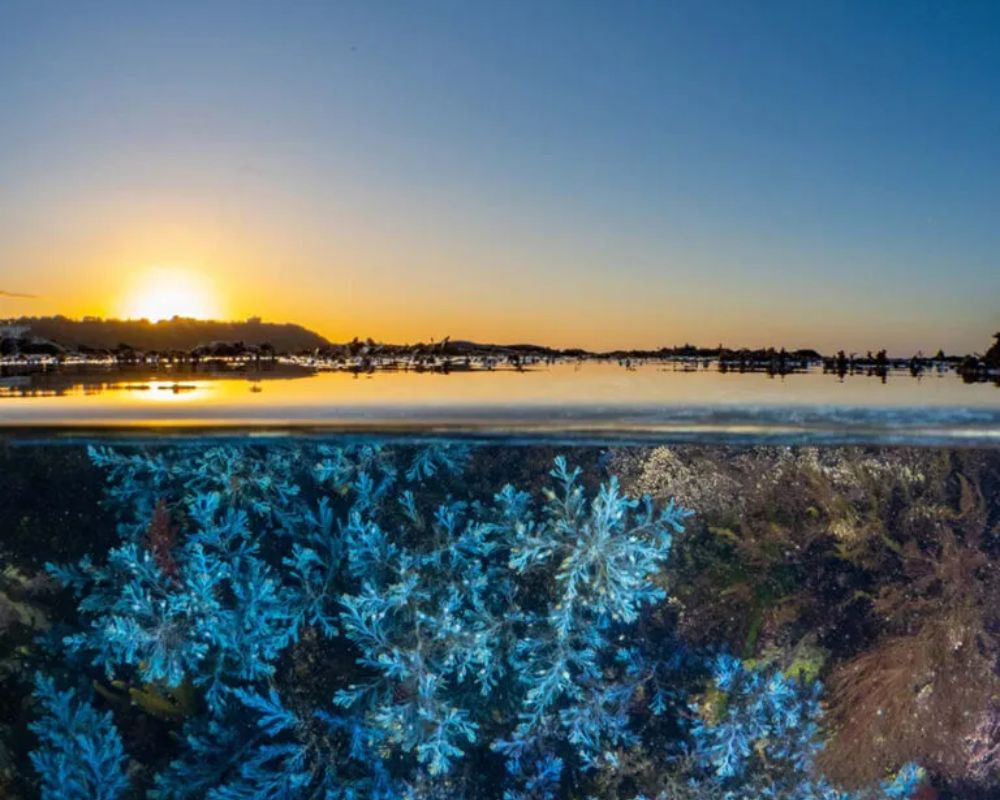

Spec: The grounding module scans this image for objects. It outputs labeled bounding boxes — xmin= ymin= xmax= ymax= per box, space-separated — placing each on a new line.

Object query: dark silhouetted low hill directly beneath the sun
xmin=7 ymin=316 xmax=330 ymax=353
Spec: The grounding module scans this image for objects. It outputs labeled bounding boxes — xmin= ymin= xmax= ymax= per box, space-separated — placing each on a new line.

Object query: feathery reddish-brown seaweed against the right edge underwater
xmin=825 ymin=466 xmax=1000 ymax=784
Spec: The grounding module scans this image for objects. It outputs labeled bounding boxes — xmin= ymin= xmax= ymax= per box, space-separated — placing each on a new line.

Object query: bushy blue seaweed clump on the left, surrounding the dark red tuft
xmin=51 ymin=492 xmax=296 ymax=707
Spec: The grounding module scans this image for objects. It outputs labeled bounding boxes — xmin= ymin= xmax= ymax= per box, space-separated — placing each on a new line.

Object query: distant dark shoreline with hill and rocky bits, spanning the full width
xmin=0 ymin=316 xmax=1000 ymax=380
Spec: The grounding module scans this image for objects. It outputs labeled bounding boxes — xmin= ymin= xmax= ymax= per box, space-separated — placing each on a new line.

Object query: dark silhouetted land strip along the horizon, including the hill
xmin=0 ymin=315 xmax=1000 ymax=377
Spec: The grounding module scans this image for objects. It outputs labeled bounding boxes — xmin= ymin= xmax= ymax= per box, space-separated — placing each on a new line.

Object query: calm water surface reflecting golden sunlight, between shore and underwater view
xmin=0 ymin=362 xmax=1000 ymax=444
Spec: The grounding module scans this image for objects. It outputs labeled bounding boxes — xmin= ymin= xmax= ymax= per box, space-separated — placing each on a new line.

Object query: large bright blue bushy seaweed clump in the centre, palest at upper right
xmin=335 ymin=458 xmax=687 ymax=791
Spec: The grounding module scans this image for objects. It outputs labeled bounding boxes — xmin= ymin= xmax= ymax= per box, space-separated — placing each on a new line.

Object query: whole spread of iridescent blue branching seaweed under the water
xmin=27 ymin=443 xmax=921 ymax=800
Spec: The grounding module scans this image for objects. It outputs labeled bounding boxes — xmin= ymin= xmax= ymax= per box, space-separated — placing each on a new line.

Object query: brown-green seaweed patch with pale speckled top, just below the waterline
xmin=615 ymin=446 xmax=950 ymax=658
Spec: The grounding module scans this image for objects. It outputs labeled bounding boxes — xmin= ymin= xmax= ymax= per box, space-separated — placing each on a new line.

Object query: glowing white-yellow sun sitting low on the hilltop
xmin=121 ymin=267 xmax=222 ymax=322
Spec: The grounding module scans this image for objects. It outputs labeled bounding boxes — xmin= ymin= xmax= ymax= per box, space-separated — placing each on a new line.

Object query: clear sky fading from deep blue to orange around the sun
xmin=0 ymin=0 xmax=1000 ymax=354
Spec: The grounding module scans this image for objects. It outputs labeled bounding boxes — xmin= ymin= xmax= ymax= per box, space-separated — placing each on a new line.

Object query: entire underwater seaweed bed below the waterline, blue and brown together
xmin=0 ymin=434 xmax=1000 ymax=800
